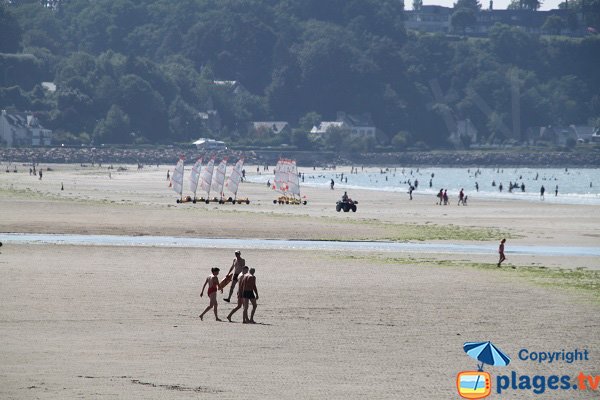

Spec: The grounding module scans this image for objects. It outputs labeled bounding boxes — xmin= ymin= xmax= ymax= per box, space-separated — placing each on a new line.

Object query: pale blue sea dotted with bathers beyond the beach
xmin=248 ymin=167 xmax=600 ymax=205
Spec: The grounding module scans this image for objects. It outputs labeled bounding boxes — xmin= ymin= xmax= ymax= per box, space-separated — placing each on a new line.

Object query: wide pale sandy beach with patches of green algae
xmin=0 ymin=165 xmax=600 ymax=399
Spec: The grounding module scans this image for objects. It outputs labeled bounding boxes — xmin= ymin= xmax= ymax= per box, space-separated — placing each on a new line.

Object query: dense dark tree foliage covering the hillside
xmin=0 ymin=0 xmax=600 ymax=151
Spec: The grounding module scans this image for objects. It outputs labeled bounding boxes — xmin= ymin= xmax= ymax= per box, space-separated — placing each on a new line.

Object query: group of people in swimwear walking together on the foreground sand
xmin=199 ymin=250 xmax=258 ymax=324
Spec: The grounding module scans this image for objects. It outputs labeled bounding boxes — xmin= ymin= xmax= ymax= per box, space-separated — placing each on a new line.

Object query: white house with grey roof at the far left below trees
xmin=0 ymin=110 xmax=52 ymax=147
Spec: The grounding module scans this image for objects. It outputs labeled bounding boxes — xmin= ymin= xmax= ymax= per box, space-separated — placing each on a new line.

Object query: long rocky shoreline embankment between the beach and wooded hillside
xmin=0 ymin=146 xmax=600 ymax=168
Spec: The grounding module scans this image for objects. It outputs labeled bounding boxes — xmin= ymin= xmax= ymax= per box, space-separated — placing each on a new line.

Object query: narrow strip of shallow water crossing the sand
xmin=0 ymin=233 xmax=600 ymax=257
